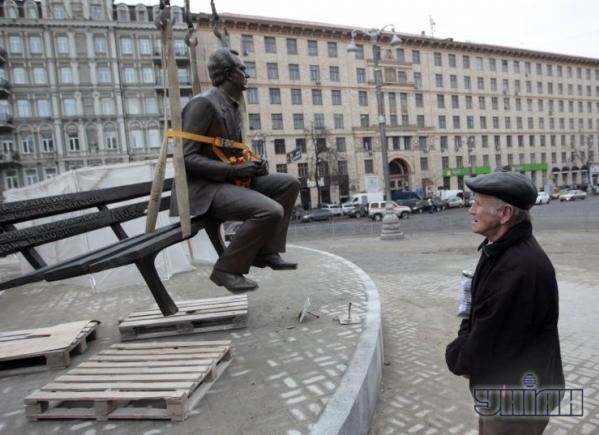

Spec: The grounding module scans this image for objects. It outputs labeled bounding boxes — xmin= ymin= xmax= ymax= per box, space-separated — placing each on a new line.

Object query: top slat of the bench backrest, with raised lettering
xmin=0 ymin=178 xmax=173 ymax=225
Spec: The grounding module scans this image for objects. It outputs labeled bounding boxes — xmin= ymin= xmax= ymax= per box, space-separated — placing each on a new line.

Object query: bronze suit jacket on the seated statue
xmin=171 ymin=87 xmax=241 ymax=216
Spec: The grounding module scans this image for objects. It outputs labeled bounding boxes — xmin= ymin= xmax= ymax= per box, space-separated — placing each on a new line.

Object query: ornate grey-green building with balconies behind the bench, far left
xmin=0 ymin=0 xmax=191 ymax=191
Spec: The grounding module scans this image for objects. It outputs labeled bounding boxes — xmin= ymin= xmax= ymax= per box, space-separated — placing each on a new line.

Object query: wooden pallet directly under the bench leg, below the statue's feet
xmin=119 ymin=295 xmax=248 ymax=341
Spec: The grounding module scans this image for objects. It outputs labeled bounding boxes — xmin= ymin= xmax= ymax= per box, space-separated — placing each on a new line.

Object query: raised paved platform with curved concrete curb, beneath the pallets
xmin=0 ymin=247 xmax=383 ymax=435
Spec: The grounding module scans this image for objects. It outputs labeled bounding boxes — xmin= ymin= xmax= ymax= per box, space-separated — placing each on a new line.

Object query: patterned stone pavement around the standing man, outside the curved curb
xmin=305 ymin=230 xmax=599 ymax=435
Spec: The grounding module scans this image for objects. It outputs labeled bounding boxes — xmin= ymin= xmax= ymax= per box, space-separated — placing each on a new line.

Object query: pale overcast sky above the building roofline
xmin=123 ymin=0 xmax=599 ymax=59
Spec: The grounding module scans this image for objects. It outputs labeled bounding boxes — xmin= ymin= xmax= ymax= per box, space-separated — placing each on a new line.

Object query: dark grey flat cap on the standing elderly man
xmin=465 ymin=171 xmax=537 ymax=210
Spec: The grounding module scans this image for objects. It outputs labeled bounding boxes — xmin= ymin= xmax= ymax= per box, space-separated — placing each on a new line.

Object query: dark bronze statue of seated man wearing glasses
xmin=171 ymin=48 xmax=299 ymax=292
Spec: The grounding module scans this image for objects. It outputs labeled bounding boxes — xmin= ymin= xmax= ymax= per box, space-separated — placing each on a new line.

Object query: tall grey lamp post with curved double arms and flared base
xmin=347 ymin=24 xmax=403 ymax=240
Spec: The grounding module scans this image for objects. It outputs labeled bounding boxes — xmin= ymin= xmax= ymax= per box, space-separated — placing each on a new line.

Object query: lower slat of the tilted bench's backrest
xmin=0 ymin=197 xmax=170 ymax=257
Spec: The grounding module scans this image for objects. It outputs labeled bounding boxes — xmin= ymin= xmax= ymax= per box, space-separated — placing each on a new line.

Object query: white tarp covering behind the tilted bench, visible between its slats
xmin=4 ymin=161 xmax=216 ymax=290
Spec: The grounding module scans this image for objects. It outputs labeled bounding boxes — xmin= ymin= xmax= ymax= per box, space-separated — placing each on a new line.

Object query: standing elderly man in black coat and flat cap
xmin=445 ymin=172 xmax=564 ymax=435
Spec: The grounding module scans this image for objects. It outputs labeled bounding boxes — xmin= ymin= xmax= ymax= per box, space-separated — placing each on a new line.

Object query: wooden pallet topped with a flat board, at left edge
xmin=0 ymin=320 xmax=100 ymax=376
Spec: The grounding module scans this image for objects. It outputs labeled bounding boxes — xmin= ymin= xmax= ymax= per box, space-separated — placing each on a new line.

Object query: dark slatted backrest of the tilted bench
xmin=0 ymin=179 xmax=172 ymax=269
